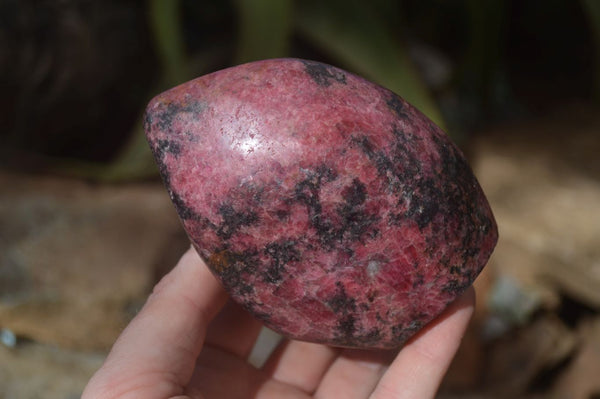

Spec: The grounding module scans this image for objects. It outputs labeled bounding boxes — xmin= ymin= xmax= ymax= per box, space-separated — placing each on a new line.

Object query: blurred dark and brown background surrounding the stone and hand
xmin=0 ymin=0 xmax=600 ymax=399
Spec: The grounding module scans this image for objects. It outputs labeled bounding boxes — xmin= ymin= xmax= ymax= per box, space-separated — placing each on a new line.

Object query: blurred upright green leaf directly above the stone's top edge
xmin=236 ymin=0 xmax=292 ymax=63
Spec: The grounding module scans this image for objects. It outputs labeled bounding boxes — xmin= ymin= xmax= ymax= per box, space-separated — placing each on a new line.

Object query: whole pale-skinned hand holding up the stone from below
xmin=82 ymin=250 xmax=475 ymax=399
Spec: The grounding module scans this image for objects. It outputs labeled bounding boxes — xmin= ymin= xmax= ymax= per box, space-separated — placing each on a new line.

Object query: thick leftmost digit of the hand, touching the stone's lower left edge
xmin=82 ymin=249 xmax=227 ymax=399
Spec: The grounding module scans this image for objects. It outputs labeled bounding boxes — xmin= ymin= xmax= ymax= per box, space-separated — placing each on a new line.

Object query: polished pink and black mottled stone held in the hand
xmin=145 ymin=59 xmax=497 ymax=348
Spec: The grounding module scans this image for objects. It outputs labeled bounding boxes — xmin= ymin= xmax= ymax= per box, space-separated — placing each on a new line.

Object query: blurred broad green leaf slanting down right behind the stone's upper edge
xmin=295 ymin=0 xmax=445 ymax=128
